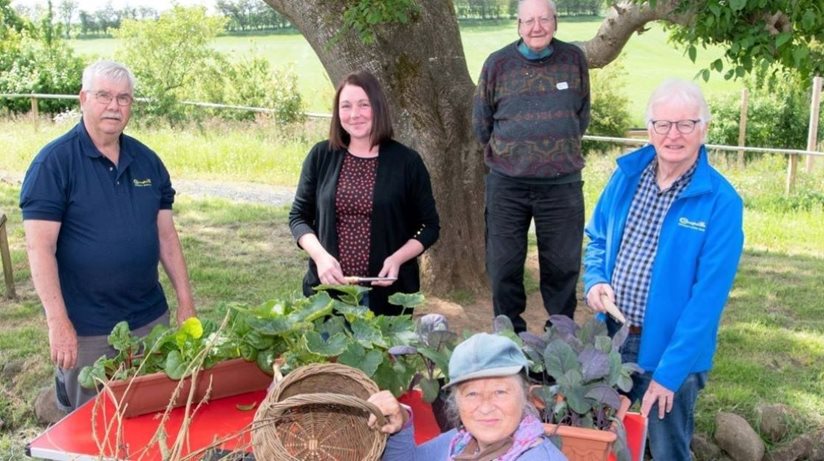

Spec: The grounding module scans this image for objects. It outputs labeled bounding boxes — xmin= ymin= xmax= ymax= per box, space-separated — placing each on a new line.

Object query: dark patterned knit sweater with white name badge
xmin=472 ymin=39 xmax=590 ymax=178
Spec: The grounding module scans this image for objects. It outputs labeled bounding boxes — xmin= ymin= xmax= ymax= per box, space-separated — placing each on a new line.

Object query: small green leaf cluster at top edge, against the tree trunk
xmin=343 ymin=0 xmax=420 ymax=45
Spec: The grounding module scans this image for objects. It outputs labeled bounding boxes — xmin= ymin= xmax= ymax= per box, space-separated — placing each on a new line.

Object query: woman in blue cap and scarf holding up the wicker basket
xmin=369 ymin=333 xmax=566 ymax=461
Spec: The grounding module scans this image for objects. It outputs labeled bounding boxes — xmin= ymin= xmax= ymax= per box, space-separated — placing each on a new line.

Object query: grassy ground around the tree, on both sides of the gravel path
xmin=0 ymin=116 xmax=824 ymax=459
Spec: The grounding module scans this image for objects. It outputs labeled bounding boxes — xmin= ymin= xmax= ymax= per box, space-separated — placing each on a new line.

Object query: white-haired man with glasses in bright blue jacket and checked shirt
xmin=584 ymin=80 xmax=744 ymax=461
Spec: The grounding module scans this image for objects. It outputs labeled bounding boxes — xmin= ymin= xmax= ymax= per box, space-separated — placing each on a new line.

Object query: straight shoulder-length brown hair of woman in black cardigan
xmin=329 ymin=71 xmax=393 ymax=149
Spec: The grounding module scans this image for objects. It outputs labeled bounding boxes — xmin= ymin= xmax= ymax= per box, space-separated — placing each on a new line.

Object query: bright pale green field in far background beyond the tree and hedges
xmin=71 ymin=18 xmax=742 ymax=124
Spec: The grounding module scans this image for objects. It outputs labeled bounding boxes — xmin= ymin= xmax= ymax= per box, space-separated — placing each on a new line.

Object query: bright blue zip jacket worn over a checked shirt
xmin=584 ymin=145 xmax=744 ymax=391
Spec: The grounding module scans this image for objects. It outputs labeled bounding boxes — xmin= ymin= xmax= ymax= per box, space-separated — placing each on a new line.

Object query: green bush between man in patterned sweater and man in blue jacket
xmin=582 ymin=59 xmax=632 ymax=154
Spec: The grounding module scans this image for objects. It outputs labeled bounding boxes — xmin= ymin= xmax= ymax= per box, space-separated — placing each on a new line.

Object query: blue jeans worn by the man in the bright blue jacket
xmin=621 ymin=328 xmax=707 ymax=461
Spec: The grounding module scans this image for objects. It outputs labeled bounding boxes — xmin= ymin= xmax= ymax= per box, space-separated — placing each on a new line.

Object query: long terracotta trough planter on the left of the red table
xmin=104 ymin=359 xmax=272 ymax=418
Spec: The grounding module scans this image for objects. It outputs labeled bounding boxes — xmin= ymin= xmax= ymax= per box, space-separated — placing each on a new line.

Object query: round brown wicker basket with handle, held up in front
xmin=252 ymin=363 xmax=386 ymax=461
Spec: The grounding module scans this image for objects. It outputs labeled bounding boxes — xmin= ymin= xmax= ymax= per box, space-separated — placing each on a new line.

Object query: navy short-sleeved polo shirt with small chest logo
xmin=20 ymin=120 xmax=175 ymax=336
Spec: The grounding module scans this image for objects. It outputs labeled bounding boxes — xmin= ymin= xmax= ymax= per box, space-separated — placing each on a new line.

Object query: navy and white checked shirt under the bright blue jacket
xmin=612 ymin=159 xmax=697 ymax=326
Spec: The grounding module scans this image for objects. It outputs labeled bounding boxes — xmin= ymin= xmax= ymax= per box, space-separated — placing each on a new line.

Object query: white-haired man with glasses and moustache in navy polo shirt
xmin=20 ymin=61 xmax=195 ymax=411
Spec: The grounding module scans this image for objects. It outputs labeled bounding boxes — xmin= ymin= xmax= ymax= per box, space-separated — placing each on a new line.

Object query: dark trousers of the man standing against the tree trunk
xmin=485 ymin=174 xmax=584 ymax=332
